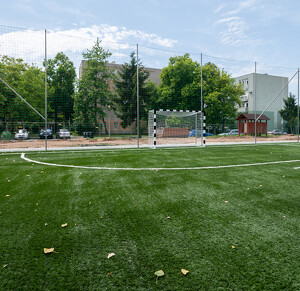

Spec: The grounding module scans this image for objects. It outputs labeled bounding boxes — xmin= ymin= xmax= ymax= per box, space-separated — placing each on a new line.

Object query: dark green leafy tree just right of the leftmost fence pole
xmin=47 ymin=52 xmax=76 ymax=128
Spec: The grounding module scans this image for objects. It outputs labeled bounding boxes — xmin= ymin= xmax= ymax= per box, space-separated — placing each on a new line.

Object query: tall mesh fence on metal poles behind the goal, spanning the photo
xmin=0 ymin=26 xmax=299 ymax=150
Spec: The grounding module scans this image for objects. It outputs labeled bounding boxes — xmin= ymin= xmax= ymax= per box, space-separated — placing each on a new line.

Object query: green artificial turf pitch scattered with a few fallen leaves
xmin=0 ymin=144 xmax=300 ymax=290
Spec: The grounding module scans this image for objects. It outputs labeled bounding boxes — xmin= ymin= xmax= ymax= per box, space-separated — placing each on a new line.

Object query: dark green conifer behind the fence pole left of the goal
xmin=114 ymin=52 xmax=156 ymax=133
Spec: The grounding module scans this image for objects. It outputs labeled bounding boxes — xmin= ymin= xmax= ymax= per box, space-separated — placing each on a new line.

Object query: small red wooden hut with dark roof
xmin=236 ymin=113 xmax=270 ymax=135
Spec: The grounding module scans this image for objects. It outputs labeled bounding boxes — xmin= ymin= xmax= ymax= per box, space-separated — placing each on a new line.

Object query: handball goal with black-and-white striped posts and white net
xmin=148 ymin=109 xmax=206 ymax=148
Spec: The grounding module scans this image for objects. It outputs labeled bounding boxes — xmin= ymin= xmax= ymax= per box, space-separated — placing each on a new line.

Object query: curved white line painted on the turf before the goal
xmin=21 ymin=153 xmax=300 ymax=171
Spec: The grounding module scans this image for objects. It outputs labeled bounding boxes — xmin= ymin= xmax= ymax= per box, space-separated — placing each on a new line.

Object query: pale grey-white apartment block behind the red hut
xmin=235 ymin=73 xmax=288 ymax=130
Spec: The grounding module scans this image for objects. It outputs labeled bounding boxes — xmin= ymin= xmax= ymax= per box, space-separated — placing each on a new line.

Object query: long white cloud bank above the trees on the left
xmin=0 ymin=24 xmax=176 ymax=73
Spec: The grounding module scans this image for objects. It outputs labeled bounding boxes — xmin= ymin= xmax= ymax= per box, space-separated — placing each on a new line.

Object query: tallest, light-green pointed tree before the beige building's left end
xmin=74 ymin=39 xmax=114 ymax=132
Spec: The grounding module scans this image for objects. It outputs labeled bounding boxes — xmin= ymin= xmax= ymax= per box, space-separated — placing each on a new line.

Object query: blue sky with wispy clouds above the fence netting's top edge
xmin=0 ymin=0 xmax=300 ymax=89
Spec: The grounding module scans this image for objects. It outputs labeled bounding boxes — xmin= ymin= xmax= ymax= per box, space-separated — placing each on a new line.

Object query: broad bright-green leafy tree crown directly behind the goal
xmin=157 ymin=54 xmax=244 ymax=131
